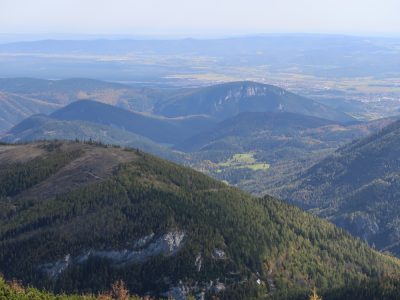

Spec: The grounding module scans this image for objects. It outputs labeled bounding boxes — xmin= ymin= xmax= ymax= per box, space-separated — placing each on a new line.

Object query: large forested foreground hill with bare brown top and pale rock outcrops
xmin=0 ymin=142 xmax=400 ymax=299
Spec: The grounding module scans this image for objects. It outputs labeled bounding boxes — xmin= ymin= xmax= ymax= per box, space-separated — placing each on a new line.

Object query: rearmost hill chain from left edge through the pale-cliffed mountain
xmin=0 ymin=78 xmax=354 ymax=132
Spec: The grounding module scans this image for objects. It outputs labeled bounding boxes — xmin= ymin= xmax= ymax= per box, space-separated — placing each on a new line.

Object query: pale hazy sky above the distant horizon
xmin=0 ymin=0 xmax=400 ymax=36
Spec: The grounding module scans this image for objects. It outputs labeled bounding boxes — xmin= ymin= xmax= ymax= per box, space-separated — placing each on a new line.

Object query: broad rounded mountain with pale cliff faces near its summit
xmin=155 ymin=81 xmax=354 ymax=122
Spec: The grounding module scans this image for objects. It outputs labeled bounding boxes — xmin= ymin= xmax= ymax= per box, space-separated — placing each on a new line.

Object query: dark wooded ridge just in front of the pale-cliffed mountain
xmin=178 ymin=112 xmax=395 ymax=151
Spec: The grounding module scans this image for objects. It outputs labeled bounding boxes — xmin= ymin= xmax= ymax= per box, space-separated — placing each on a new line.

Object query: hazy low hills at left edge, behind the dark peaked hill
xmin=0 ymin=78 xmax=172 ymax=132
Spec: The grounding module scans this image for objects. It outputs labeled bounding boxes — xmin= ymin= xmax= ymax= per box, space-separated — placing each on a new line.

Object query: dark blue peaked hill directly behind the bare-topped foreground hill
xmin=0 ymin=100 xmax=216 ymax=161
